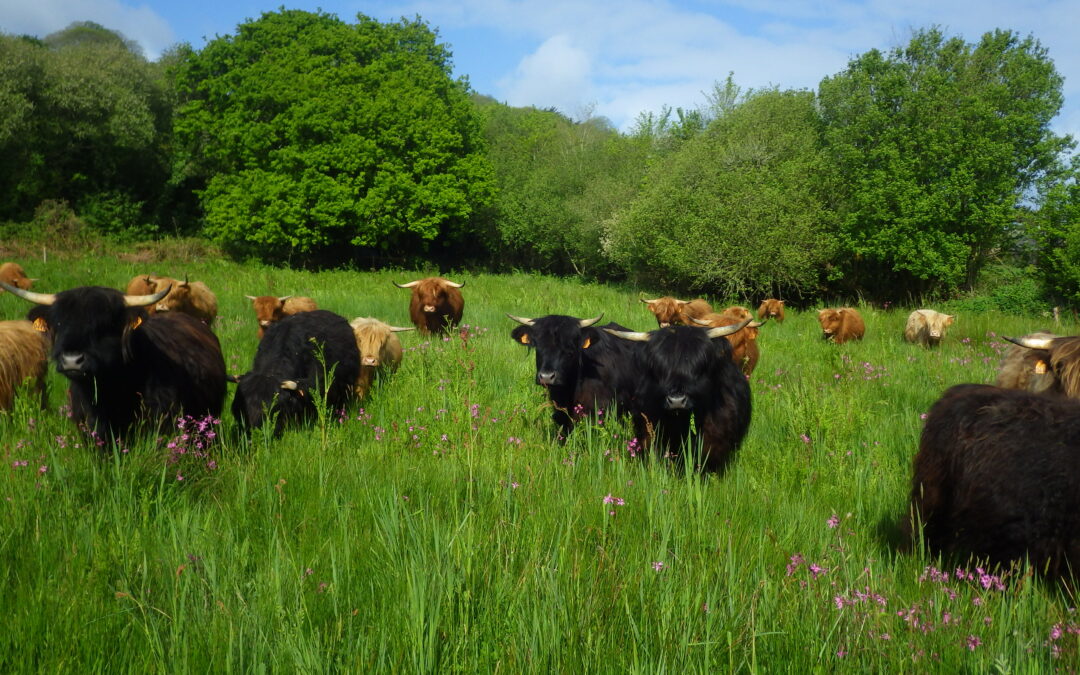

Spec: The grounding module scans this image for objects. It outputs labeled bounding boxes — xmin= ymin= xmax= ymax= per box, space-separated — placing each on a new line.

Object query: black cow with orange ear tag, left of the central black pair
xmin=507 ymin=314 xmax=638 ymax=440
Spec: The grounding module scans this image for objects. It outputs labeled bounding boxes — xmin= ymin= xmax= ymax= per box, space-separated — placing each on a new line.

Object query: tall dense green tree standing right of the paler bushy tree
xmin=819 ymin=28 xmax=1068 ymax=295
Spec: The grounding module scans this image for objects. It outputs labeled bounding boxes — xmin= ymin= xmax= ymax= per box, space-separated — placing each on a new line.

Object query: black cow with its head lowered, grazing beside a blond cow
xmin=232 ymin=309 xmax=360 ymax=435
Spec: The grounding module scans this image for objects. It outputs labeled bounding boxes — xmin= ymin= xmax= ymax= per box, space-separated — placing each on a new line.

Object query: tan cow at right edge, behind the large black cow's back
xmin=995 ymin=333 xmax=1080 ymax=399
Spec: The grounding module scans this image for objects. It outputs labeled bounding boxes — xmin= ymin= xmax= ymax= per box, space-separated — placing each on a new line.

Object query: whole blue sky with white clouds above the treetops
xmin=0 ymin=0 xmax=1080 ymax=138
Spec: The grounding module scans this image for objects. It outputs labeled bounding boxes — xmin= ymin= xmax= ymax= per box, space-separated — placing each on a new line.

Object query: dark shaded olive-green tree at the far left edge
xmin=0 ymin=22 xmax=172 ymax=230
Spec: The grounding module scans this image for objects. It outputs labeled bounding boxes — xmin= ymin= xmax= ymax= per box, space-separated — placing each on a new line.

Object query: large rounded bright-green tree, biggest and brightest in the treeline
xmin=175 ymin=10 xmax=491 ymax=259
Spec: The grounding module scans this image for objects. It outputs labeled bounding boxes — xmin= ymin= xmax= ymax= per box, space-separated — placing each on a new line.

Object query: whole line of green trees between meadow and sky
xmin=0 ymin=10 xmax=1080 ymax=305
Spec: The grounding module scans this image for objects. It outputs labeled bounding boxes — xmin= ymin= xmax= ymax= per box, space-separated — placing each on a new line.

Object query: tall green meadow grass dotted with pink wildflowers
xmin=0 ymin=254 xmax=1080 ymax=673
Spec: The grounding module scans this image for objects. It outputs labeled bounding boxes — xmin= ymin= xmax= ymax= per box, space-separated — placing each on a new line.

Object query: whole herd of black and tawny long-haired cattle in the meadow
xmin=0 ymin=262 xmax=1080 ymax=575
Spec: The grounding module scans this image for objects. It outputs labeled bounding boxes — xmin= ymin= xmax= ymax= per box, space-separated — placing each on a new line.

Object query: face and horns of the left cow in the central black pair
xmin=508 ymin=314 xmax=603 ymax=387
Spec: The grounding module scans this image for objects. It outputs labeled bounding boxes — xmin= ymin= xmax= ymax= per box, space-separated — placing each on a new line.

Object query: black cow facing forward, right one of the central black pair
xmin=612 ymin=319 xmax=751 ymax=472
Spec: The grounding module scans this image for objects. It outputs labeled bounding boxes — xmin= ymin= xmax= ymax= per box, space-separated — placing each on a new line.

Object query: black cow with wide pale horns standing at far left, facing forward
xmin=3 ymin=284 xmax=226 ymax=436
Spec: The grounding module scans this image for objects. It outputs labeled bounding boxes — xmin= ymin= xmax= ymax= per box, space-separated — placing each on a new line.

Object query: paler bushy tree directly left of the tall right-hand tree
xmin=605 ymin=90 xmax=833 ymax=297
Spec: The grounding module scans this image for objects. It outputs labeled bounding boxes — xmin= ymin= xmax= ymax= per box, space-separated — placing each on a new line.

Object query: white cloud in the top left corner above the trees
xmin=0 ymin=0 xmax=176 ymax=59
